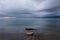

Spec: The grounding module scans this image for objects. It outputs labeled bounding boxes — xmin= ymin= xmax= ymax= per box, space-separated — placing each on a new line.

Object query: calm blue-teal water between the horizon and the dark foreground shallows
xmin=0 ymin=18 xmax=60 ymax=33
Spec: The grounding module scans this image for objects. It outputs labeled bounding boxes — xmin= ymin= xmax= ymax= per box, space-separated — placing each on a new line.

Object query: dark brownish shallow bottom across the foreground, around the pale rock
xmin=0 ymin=32 xmax=60 ymax=40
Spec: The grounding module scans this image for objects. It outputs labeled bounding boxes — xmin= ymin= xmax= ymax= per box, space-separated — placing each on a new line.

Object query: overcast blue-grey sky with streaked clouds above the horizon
xmin=0 ymin=0 xmax=60 ymax=17
